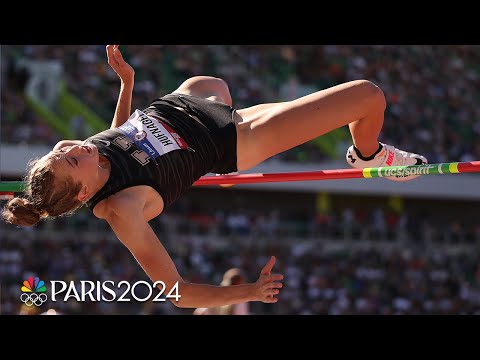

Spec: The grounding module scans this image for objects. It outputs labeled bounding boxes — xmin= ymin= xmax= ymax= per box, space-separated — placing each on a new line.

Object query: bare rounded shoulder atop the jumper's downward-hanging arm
xmin=93 ymin=185 xmax=164 ymax=221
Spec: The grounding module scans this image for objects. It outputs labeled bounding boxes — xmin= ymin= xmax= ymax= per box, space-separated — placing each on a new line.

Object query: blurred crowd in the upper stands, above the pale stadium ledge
xmin=1 ymin=45 xmax=480 ymax=163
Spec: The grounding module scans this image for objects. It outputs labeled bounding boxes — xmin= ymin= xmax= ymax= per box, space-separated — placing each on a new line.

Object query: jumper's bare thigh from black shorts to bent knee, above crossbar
xmin=238 ymin=80 xmax=385 ymax=168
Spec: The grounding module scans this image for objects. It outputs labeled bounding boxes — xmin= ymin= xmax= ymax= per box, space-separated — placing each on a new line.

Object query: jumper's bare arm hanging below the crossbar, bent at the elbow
xmin=101 ymin=194 xmax=283 ymax=308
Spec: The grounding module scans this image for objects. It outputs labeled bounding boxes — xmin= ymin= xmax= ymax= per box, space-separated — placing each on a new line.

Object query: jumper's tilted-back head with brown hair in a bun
xmin=2 ymin=145 xmax=98 ymax=226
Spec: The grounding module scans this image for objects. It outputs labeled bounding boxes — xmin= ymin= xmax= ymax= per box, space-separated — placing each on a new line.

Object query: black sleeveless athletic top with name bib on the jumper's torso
xmin=85 ymin=107 xmax=218 ymax=211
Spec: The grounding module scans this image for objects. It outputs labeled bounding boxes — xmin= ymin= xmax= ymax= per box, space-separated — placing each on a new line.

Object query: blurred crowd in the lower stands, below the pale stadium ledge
xmin=0 ymin=200 xmax=480 ymax=315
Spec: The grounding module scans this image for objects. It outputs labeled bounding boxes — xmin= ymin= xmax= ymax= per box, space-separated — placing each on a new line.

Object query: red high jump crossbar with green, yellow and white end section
xmin=0 ymin=161 xmax=480 ymax=193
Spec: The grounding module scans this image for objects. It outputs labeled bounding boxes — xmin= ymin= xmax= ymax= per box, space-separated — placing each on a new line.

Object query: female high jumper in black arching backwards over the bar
xmin=3 ymin=45 xmax=427 ymax=308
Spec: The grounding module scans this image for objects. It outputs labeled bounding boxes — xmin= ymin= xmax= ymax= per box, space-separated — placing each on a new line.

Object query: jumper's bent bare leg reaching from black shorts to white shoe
xmin=237 ymin=80 xmax=426 ymax=180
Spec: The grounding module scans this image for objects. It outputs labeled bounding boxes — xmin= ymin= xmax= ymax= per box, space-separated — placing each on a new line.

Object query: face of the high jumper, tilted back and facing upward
xmin=45 ymin=144 xmax=98 ymax=200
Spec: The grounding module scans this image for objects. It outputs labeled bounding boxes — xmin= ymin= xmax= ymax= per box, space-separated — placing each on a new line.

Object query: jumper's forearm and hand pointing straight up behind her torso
xmin=107 ymin=45 xmax=135 ymax=129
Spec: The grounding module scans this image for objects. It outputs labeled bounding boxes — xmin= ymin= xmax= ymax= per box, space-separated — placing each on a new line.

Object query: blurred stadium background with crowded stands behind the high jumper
xmin=0 ymin=45 xmax=480 ymax=315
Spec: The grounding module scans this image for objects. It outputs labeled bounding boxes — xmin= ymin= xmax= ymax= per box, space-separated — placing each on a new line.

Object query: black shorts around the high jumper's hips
xmin=144 ymin=93 xmax=237 ymax=174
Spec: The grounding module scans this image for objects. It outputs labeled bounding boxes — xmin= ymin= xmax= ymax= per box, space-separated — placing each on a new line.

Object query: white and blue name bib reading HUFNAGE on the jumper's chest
xmin=118 ymin=110 xmax=188 ymax=158
